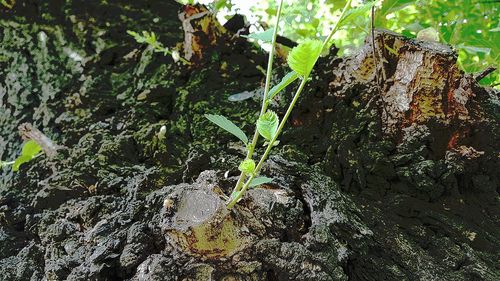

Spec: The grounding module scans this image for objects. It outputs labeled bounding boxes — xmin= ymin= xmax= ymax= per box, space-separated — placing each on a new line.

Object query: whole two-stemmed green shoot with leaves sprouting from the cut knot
xmin=206 ymin=0 xmax=356 ymax=206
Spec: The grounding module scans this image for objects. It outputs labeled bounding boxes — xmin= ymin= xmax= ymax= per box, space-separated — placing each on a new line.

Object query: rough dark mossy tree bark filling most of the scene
xmin=0 ymin=0 xmax=500 ymax=281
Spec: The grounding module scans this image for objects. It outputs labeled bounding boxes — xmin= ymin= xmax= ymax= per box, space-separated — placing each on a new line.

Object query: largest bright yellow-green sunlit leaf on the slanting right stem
xmin=288 ymin=40 xmax=323 ymax=76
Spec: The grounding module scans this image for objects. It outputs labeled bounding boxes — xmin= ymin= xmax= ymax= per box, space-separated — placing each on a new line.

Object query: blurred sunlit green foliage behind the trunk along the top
xmin=178 ymin=0 xmax=500 ymax=88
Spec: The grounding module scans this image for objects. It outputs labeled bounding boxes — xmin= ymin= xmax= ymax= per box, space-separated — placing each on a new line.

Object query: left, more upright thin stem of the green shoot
xmin=233 ymin=0 xmax=283 ymax=193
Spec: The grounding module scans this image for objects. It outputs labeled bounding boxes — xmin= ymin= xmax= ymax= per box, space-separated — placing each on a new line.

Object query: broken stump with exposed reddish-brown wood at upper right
xmin=331 ymin=30 xmax=487 ymax=156
